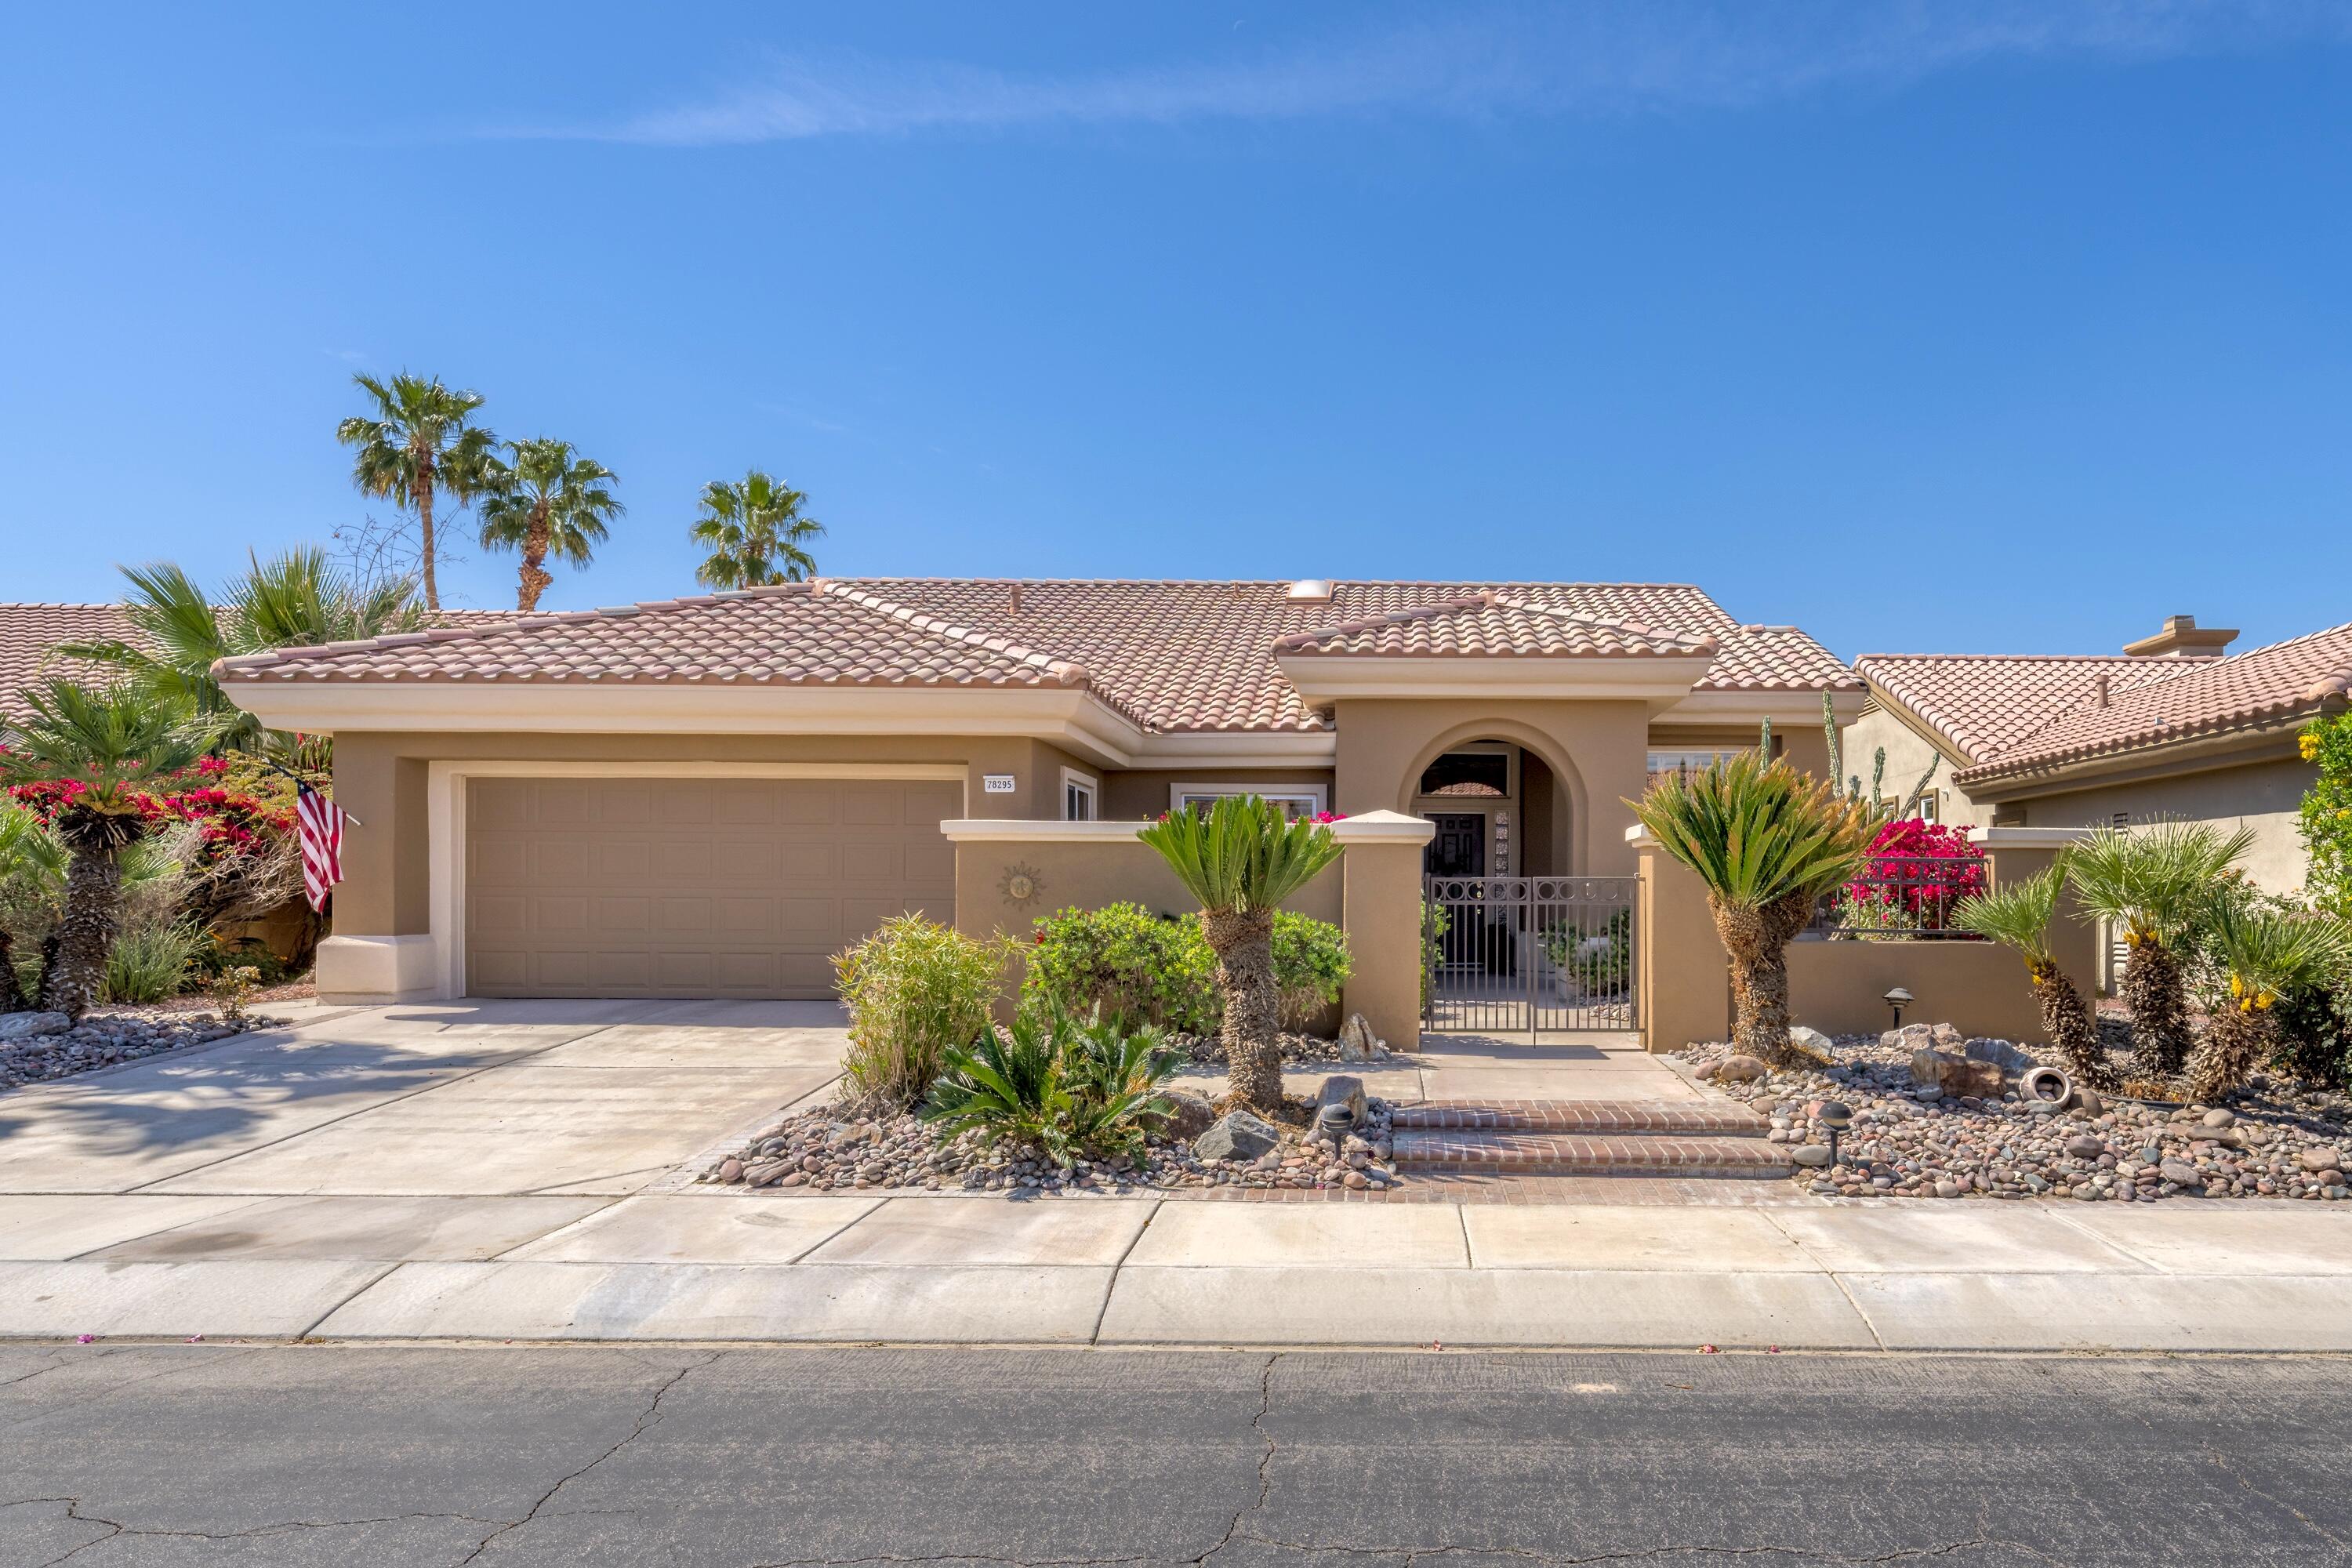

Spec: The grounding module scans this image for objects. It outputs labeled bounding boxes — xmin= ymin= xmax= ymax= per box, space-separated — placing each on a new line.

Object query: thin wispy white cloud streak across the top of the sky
xmin=487 ymin=0 xmax=2352 ymax=146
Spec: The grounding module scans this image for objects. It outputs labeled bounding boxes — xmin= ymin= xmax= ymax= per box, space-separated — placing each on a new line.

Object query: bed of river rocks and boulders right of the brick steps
xmin=1679 ymin=1025 xmax=2352 ymax=1203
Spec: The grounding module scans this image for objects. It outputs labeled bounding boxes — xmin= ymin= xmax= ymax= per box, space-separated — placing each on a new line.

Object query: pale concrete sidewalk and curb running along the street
xmin=0 ymin=1192 xmax=2352 ymax=1352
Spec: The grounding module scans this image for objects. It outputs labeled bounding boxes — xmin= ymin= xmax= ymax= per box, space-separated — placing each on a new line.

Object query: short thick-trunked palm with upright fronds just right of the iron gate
xmin=1625 ymin=750 xmax=1882 ymax=1067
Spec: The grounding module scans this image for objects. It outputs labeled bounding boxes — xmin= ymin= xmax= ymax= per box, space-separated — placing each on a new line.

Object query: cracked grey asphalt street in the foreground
xmin=0 ymin=1345 xmax=2352 ymax=1568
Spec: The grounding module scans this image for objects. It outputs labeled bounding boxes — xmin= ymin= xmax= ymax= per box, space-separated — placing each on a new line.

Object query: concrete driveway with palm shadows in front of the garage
xmin=0 ymin=1001 xmax=842 ymax=1196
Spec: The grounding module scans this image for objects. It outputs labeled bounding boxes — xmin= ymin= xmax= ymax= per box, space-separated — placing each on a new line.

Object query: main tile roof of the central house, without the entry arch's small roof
xmin=216 ymin=579 xmax=1860 ymax=731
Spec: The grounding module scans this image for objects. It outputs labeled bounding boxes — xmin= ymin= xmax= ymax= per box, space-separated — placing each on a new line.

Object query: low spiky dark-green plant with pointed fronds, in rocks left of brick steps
xmin=924 ymin=1006 xmax=1176 ymax=1168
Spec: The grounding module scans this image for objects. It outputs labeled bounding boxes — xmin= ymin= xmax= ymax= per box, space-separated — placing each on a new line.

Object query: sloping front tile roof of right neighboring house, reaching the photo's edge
xmin=1959 ymin=626 xmax=2352 ymax=783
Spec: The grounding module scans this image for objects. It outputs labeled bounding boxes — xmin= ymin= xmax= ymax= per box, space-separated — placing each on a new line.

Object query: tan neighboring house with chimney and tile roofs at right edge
xmin=1842 ymin=616 xmax=2352 ymax=893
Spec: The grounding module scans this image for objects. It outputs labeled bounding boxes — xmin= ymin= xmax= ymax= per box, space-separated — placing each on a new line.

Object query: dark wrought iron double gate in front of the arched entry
xmin=1421 ymin=877 xmax=1642 ymax=1034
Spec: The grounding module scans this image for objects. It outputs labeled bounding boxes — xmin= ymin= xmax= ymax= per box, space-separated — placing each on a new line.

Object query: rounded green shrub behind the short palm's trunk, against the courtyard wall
xmin=1023 ymin=902 xmax=1348 ymax=1034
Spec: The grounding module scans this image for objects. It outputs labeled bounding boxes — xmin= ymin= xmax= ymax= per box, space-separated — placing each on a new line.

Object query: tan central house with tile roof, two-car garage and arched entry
xmin=221 ymin=579 xmax=1863 ymax=996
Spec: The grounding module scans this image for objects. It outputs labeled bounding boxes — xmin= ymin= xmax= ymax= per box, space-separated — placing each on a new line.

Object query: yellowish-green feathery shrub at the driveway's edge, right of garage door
xmin=833 ymin=914 xmax=1009 ymax=1109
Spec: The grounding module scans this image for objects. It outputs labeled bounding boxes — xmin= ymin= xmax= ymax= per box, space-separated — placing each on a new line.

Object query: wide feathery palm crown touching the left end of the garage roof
xmin=56 ymin=546 xmax=426 ymax=750
